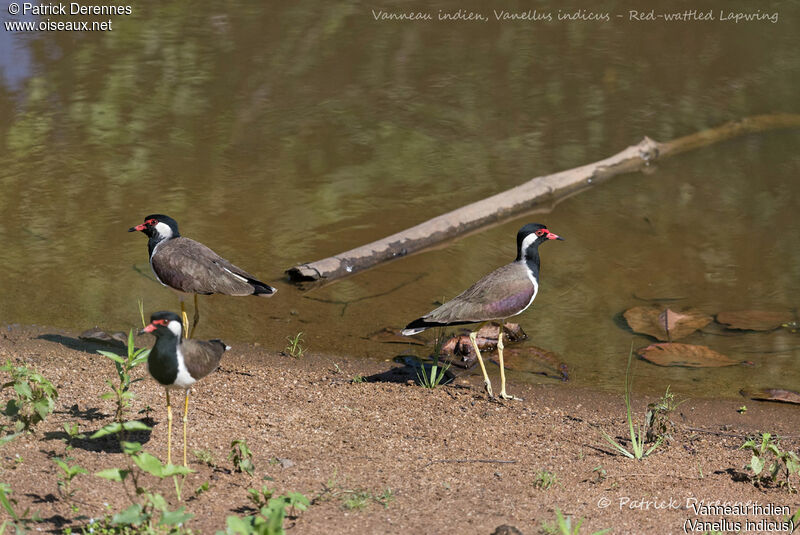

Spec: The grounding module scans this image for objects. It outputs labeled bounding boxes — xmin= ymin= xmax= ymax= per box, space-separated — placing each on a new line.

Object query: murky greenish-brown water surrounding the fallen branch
xmin=0 ymin=1 xmax=800 ymax=396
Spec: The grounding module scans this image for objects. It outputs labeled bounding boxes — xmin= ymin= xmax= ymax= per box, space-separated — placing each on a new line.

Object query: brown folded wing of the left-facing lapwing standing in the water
xmin=150 ymin=237 xmax=255 ymax=295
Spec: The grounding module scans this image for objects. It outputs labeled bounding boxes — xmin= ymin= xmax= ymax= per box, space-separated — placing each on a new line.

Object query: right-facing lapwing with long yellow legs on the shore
xmin=403 ymin=223 xmax=564 ymax=399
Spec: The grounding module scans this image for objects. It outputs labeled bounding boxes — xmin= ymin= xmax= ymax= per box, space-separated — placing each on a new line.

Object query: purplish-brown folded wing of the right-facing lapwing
xmin=423 ymin=262 xmax=536 ymax=323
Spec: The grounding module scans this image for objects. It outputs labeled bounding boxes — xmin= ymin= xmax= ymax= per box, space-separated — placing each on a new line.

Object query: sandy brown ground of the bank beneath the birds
xmin=0 ymin=326 xmax=800 ymax=535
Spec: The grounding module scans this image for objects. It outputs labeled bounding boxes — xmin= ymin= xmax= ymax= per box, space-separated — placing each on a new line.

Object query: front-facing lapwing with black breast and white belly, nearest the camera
xmin=144 ymin=311 xmax=230 ymax=466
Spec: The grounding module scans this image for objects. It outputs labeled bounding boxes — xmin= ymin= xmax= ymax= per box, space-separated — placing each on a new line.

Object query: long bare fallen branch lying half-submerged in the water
xmin=286 ymin=114 xmax=800 ymax=282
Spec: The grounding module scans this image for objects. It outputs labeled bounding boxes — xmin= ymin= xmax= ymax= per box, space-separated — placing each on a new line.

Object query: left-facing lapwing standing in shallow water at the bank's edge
xmin=128 ymin=214 xmax=278 ymax=338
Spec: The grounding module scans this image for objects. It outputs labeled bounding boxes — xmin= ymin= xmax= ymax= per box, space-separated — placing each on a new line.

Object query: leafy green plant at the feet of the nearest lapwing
xmin=95 ymin=441 xmax=193 ymax=533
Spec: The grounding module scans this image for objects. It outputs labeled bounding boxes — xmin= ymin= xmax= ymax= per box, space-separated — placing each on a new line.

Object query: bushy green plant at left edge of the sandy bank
xmin=0 ymin=360 xmax=58 ymax=434
